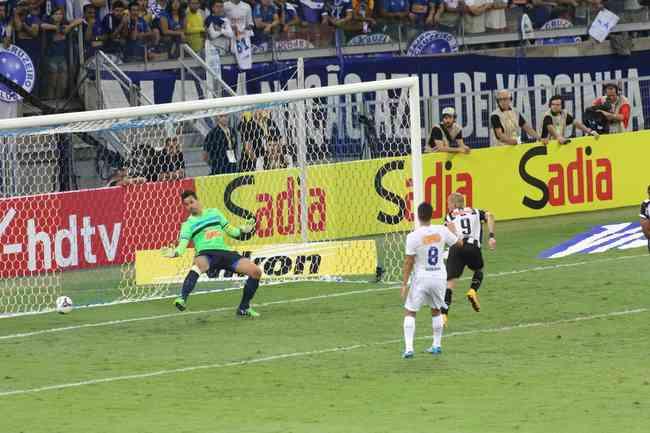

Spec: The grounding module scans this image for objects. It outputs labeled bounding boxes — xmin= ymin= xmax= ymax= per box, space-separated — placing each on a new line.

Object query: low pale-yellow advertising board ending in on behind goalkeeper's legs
xmin=135 ymin=240 xmax=377 ymax=285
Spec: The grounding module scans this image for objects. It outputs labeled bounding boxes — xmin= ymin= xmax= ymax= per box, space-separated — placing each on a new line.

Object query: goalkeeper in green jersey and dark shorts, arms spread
xmin=162 ymin=190 xmax=262 ymax=317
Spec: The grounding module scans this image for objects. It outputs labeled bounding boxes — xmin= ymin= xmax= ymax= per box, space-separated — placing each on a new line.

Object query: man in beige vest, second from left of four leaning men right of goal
xmin=490 ymin=90 xmax=539 ymax=146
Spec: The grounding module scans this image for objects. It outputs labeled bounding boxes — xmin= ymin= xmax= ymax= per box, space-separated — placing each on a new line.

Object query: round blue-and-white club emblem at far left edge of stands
xmin=0 ymin=45 xmax=36 ymax=102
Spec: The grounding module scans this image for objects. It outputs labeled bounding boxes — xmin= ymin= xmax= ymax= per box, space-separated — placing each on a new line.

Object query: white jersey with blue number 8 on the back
xmin=406 ymin=225 xmax=458 ymax=280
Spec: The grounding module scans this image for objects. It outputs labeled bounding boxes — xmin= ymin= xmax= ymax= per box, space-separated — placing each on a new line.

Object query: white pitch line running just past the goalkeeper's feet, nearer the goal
xmin=0 ymin=254 xmax=648 ymax=342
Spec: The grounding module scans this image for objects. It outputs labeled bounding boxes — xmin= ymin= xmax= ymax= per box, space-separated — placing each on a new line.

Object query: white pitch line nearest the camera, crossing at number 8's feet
xmin=0 ymin=308 xmax=649 ymax=397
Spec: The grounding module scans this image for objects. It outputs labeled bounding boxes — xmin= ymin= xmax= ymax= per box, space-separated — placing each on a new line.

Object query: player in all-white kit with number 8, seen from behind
xmin=400 ymin=203 xmax=458 ymax=359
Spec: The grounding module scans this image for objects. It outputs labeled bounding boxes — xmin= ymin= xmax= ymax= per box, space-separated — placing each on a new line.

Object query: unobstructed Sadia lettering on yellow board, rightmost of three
xmin=519 ymin=146 xmax=614 ymax=209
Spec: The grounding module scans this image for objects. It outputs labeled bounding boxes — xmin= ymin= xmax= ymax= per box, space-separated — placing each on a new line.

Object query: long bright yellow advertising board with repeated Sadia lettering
xmin=196 ymin=131 xmax=650 ymax=244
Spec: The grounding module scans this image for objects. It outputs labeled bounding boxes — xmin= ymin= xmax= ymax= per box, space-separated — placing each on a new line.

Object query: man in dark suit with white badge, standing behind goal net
xmin=203 ymin=114 xmax=237 ymax=175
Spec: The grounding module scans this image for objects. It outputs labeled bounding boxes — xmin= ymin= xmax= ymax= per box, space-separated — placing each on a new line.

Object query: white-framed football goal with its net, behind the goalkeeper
xmin=0 ymin=78 xmax=422 ymax=315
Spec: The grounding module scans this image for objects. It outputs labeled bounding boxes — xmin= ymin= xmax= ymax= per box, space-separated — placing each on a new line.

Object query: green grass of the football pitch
xmin=0 ymin=208 xmax=650 ymax=433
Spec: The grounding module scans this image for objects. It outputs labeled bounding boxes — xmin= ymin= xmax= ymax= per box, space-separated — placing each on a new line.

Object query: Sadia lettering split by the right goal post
xmin=375 ymin=159 xmax=473 ymax=225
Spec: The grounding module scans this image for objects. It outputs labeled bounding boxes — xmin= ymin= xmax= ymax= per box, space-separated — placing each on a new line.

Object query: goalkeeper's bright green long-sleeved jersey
xmin=176 ymin=209 xmax=241 ymax=256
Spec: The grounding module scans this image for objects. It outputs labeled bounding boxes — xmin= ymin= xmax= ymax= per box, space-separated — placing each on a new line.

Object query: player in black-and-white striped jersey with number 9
xmin=442 ymin=192 xmax=497 ymax=324
